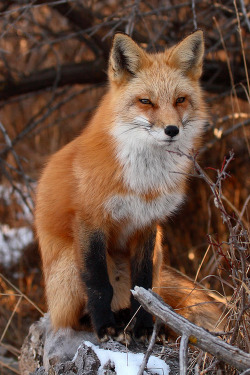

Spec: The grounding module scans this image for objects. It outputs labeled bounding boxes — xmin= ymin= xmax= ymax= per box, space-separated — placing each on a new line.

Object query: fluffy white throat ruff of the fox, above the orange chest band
xmin=112 ymin=123 xmax=190 ymax=195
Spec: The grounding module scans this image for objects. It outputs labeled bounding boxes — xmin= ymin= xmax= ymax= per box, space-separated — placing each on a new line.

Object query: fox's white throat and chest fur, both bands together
xmin=104 ymin=123 xmax=189 ymax=233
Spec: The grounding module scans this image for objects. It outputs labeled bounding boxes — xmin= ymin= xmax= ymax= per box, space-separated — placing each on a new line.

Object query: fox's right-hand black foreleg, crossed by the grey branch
xmin=131 ymin=230 xmax=156 ymax=337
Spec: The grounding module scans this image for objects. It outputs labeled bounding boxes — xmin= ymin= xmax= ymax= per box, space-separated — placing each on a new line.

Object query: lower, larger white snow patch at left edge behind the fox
xmin=0 ymin=224 xmax=33 ymax=267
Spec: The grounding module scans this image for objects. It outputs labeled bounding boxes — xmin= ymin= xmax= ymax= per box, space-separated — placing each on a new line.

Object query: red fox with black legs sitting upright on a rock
xmin=35 ymin=30 xmax=223 ymax=340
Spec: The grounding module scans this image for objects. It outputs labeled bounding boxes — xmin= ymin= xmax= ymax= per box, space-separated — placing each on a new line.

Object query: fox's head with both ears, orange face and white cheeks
xmin=109 ymin=30 xmax=206 ymax=157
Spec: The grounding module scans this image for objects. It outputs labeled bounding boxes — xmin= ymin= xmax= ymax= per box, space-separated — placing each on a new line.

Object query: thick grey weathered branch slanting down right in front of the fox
xmin=132 ymin=286 xmax=250 ymax=371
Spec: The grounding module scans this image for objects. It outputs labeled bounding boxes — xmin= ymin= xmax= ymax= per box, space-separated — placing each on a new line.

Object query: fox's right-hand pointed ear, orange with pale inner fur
xmin=168 ymin=30 xmax=204 ymax=79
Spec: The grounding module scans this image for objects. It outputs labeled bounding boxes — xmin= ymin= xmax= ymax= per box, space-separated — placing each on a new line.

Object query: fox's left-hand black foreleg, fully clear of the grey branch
xmin=82 ymin=231 xmax=115 ymax=339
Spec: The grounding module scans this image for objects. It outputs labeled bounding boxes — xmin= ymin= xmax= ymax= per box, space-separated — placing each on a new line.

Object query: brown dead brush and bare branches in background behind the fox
xmin=0 ymin=0 xmax=250 ymax=374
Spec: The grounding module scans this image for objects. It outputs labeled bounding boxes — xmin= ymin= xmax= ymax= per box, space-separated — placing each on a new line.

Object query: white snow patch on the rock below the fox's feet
xmin=84 ymin=341 xmax=169 ymax=375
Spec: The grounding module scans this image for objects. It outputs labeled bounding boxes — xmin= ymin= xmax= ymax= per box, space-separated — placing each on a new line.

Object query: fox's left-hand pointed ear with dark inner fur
xmin=109 ymin=33 xmax=147 ymax=82
